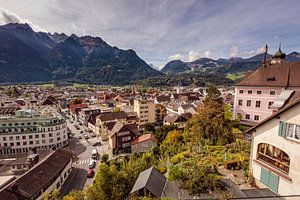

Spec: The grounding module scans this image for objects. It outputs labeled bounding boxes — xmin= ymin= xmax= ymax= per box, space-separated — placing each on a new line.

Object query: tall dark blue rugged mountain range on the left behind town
xmin=0 ymin=23 xmax=163 ymax=85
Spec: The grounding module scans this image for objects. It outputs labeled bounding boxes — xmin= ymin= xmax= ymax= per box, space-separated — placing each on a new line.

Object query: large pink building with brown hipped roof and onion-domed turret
xmin=234 ymin=48 xmax=300 ymax=125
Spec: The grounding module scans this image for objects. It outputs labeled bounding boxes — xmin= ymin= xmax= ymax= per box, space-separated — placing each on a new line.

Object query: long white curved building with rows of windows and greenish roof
xmin=0 ymin=110 xmax=68 ymax=157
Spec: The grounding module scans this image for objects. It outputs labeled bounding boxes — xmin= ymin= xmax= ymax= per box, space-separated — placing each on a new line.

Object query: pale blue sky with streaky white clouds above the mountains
xmin=0 ymin=0 xmax=300 ymax=68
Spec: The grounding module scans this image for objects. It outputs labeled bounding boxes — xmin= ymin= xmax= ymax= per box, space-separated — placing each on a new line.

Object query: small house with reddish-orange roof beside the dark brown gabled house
xmin=131 ymin=134 xmax=157 ymax=153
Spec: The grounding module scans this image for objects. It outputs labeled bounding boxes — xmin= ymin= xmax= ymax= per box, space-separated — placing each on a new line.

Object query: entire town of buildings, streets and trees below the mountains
xmin=0 ymin=48 xmax=300 ymax=199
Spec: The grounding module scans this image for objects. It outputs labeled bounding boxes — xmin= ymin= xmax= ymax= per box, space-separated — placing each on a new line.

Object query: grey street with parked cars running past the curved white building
xmin=61 ymin=115 xmax=108 ymax=195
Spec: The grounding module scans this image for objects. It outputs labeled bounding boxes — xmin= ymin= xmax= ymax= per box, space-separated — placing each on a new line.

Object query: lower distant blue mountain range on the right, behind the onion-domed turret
xmin=161 ymin=52 xmax=300 ymax=77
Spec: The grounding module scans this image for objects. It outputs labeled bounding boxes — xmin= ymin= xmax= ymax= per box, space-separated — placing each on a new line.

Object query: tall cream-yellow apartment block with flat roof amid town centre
xmin=133 ymin=99 xmax=155 ymax=129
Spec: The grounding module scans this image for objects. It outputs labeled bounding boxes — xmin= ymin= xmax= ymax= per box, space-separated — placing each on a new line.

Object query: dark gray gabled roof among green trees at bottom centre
xmin=130 ymin=167 xmax=167 ymax=197
